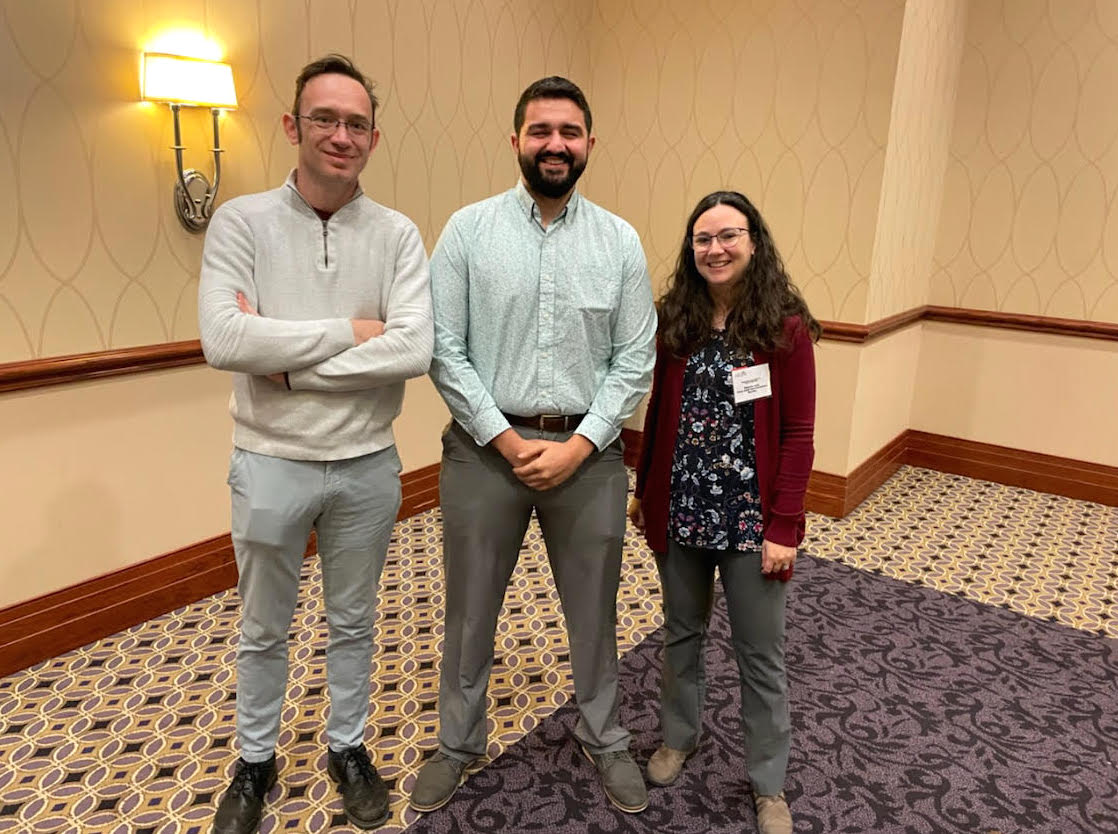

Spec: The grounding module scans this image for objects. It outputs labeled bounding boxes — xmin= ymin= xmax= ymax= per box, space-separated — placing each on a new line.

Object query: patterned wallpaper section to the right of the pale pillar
xmin=929 ymin=0 xmax=1118 ymax=322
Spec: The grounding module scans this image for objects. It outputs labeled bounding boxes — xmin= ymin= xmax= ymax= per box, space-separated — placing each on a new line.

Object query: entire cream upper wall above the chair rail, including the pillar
xmin=0 ymin=0 xmax=1118 ymax=362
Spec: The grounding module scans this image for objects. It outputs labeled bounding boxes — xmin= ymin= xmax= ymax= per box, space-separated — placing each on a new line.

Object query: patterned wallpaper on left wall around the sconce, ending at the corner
xmin=0 ymin=0 xmax=590 ymax=362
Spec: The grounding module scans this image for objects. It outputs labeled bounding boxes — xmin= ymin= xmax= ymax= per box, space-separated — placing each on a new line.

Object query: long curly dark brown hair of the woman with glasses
xmin=657 ymin=191 xmax=823 ymax=357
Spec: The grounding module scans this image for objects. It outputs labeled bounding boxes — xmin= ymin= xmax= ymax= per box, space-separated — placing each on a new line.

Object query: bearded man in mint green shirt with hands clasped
xmin=410 ymin=77 xmax=656 ymax=813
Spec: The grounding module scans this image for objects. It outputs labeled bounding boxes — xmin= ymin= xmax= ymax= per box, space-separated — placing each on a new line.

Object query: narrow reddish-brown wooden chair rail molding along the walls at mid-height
xmin=0 ymin=306 xmax=1118 ymax=392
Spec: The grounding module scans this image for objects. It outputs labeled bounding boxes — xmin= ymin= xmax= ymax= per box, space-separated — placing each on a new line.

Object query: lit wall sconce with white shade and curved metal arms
xmin=140 ymin=53 xmax=237 ymax=231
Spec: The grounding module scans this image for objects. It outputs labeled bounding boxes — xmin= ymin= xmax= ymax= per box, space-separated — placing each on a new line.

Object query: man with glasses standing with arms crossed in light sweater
xmin=199 ymin=55 xmax=433 ymax=834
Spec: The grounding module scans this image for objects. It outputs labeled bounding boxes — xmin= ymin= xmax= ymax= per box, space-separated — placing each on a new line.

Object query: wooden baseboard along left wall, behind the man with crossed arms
xmin=0 ymin=463 xmax=438 ymax=676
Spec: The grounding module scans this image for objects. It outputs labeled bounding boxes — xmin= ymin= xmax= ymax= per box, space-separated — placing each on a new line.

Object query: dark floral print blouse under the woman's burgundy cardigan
xmin=667 ymin=330 xmax=764 ymax=550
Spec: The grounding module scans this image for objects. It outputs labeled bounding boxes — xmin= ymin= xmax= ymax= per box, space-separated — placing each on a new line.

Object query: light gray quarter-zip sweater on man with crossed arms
xmin=198 ymin=172 xmax=434 ymax=461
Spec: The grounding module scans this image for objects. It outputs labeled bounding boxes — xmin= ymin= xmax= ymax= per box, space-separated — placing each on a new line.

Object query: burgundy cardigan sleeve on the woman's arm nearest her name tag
xmin=765 ymin=318 xmax=815 ymax=547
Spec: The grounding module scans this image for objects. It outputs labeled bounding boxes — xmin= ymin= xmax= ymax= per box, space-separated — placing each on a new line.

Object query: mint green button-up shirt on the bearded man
xmin=430 ymin=182 xmax=656 ymax=449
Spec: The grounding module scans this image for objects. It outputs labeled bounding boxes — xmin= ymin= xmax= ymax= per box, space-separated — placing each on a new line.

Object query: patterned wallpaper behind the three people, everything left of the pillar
xmin=0 ymin=0 xmax=903 ymax=361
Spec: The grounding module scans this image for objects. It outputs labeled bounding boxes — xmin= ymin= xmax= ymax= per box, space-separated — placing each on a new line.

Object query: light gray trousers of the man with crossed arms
xmin=229 ymin=446 xmax=400 ymax=761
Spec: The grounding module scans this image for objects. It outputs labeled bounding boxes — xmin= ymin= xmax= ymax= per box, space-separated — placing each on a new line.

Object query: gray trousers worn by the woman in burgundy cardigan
xmin=656 ymin=541 xmax=792 ymax=794
